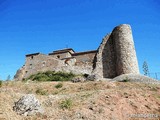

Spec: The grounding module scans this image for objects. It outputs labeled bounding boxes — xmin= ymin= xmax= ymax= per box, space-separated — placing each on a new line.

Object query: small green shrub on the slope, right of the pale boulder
xmin=60 ymin=99 xmax=73 ymax=109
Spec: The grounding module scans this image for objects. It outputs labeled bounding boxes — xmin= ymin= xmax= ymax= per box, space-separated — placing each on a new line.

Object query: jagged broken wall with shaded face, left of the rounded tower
xmin=92 ymin=34 xmax=116 ymax=79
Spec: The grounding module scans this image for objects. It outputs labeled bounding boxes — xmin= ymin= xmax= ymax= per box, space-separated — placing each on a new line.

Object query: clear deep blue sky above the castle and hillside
xmin=0 ymin=0 xmax=160 ymax=79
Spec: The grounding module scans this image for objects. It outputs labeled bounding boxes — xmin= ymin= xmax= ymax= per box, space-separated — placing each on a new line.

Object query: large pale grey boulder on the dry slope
xmin=13 ymin=94 xmax=43 ymax=116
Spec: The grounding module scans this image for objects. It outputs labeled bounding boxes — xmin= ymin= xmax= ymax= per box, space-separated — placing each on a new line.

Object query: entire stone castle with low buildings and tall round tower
xmin=15 ymin=24 xmax=139 ymax=80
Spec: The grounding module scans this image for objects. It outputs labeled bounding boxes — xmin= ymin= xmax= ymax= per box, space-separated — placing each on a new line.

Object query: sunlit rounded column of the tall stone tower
xmin=112 ymin=24 xmax=139 ymax=76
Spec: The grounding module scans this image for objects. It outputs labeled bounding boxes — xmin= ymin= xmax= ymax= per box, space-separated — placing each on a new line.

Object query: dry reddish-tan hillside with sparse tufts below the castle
xmin=0 ymin=81 xmax=160 ymax=120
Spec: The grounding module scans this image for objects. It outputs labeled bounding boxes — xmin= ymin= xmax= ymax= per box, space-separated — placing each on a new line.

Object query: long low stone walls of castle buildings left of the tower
xmin=15 ymin=53 xmax=95 ymax=80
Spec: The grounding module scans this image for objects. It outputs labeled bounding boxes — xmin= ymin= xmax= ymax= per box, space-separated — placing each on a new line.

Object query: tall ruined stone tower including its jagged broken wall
xmin=93 ymin=24 xmax=139 ymax=78
